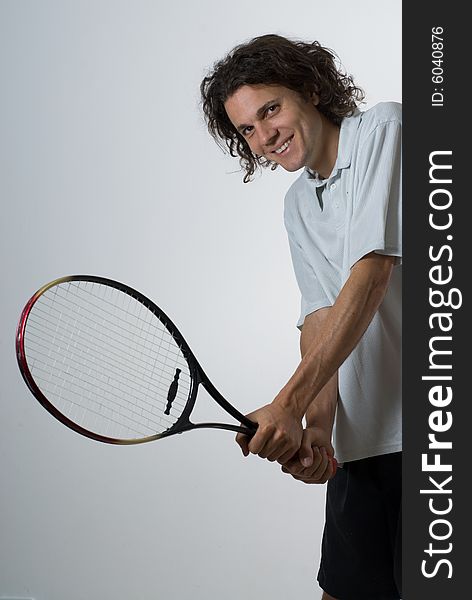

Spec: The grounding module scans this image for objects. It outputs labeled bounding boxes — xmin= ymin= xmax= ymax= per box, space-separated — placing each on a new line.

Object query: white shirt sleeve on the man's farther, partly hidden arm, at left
xmin=285 ymin=220 xmax=331 ymax=330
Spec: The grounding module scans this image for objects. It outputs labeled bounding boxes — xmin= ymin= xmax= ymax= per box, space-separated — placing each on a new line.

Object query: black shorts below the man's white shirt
xmin=318 ymin=452 xmax=402 ymax=600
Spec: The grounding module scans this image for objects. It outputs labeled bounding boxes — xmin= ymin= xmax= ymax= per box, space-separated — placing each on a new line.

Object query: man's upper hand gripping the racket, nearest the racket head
xmin=236 ymin=403 xmax=303 ymax=465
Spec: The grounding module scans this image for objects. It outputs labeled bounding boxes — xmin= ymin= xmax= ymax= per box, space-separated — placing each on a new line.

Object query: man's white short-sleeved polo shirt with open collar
xmin=284 ymin=102 xmax=402 ymax=462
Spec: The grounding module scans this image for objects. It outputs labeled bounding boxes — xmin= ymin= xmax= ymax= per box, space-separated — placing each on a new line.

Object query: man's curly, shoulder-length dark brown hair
xmin=200 ymin=34 xmax=364 ymax=183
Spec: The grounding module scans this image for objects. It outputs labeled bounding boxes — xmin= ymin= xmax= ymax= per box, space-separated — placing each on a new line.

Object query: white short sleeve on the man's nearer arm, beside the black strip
xmin=348 ymin=120 xmax=402 ymax=268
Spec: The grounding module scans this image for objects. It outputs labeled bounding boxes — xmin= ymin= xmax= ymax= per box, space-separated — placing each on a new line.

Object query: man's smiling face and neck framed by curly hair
xmin=225 ymin=85 xmax=339 ymax=177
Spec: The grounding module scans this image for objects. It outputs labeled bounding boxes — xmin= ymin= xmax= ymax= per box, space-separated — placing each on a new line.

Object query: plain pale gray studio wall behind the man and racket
xmin=0 ymin=0 xmax=401 ymax=600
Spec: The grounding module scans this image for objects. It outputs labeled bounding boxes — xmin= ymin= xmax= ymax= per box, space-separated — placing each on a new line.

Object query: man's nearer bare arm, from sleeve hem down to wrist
xmin=274 ymin=253 xmax=393 ymax=419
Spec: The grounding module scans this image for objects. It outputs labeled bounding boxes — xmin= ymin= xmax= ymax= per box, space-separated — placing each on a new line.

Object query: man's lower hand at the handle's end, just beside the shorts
xmin=282 ymin=427 xmax=337 ymax=483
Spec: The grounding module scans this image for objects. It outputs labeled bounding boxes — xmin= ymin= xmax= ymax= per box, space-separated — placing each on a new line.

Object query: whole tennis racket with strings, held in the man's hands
xmin=16 ymin=275 xmax=257 ymax=444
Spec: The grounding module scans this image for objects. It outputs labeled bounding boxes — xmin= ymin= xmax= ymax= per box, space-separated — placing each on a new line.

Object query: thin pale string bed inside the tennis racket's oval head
xmin=25 ymin=281 xmax=192 ymax=439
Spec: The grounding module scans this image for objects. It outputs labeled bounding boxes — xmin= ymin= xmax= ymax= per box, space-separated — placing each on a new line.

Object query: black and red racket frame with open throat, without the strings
xmin=16 ymin=275 xmax=257 ymax=445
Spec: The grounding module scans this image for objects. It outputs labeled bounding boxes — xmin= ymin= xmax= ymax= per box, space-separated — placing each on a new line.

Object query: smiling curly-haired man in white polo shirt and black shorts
xmin=201 ymin=35 xmax=401 ymax=600
